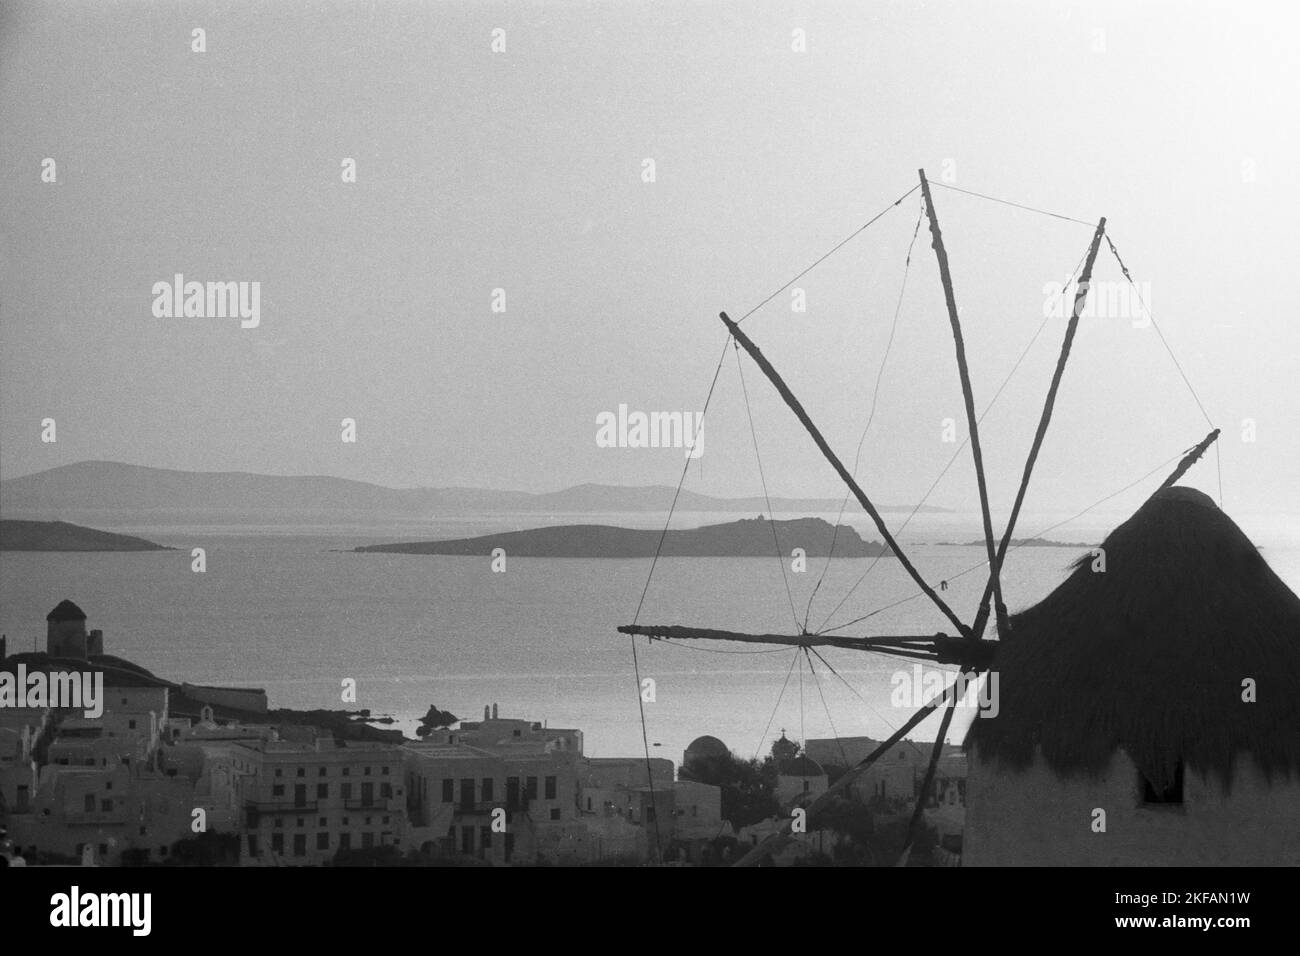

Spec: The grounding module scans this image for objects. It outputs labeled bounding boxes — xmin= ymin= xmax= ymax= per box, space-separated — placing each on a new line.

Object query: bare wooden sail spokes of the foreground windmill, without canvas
xmin=618 ymin=169 xmax=1219 ymax=866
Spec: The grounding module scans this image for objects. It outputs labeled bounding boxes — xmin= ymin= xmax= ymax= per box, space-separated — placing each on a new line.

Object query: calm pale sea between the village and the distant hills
xmin=0 ymin=514 xmax=1300 ymax=762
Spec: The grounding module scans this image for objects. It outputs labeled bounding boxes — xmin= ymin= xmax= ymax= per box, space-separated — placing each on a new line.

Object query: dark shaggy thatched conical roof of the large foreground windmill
xmin=966 ymin=488 xmax=1300 ymax=788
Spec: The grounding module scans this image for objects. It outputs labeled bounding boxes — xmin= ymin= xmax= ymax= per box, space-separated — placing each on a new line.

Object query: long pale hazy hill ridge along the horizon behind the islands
xmin=0 ymin=462 xmax=943 ymax=525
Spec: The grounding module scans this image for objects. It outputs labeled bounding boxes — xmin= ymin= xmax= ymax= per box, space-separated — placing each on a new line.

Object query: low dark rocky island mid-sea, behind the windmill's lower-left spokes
xmin=354 ymin=516 xmax=891 ymax=558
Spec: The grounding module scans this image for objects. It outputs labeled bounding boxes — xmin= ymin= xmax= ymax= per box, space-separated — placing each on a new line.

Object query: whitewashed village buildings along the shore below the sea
xmin=0 ymin=600 xmax=965 ymax=866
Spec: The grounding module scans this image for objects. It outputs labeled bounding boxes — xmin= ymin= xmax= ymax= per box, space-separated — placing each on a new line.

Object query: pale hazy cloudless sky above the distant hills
xmin=0 ymin=0 xmax=1300 ymax=514
